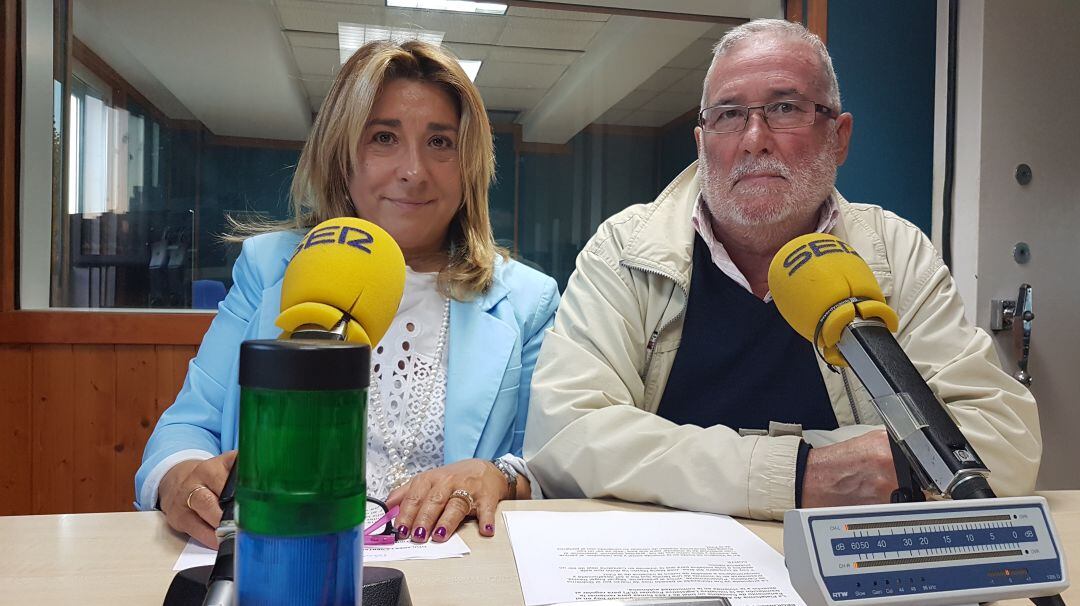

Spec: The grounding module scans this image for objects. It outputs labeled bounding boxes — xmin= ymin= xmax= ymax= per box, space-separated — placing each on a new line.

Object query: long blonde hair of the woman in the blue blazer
xmin=233 ymin=40 xmax=507 ymax=300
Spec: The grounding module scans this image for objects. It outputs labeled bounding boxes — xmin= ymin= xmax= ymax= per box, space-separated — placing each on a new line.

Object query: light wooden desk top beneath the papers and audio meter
xmin=0 ymin=490 xmax=1080 ymax=606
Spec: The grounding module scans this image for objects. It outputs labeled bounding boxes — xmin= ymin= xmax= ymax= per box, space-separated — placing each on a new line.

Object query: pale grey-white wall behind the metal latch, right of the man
xmin=939 ymin=0 xmax=1080 ymax=488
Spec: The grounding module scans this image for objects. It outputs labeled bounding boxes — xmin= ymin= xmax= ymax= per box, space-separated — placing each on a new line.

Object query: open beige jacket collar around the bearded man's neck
xmin=620 ymin=161 xmax=893 ymax=298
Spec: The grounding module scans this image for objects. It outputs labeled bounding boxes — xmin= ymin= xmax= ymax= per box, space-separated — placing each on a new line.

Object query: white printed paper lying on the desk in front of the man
xmin=502 ymin=511 xmax=805 ymax=606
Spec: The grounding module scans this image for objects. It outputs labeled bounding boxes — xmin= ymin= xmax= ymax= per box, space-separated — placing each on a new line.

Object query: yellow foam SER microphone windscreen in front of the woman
xmin=275 ymin=217 xmax=405 ymax=346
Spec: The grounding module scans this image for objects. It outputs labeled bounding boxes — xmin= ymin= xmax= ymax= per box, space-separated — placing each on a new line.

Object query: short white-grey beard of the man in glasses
xmin=699 ymin=133 xmax=836 ymax=227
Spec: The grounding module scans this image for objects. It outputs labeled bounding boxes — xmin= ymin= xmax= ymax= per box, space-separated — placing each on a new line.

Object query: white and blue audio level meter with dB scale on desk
xmin=784 ymin=497 xmax=1069 ymax=606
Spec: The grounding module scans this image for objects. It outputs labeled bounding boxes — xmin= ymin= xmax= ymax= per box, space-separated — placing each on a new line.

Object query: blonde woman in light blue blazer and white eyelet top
xmin=135 ymin=41 xmax=558 ymax=546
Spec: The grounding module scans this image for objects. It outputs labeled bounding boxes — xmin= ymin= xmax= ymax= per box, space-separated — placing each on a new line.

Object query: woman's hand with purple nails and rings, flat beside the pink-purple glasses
xmin=387 ymin=459 xmax=515 ymax=543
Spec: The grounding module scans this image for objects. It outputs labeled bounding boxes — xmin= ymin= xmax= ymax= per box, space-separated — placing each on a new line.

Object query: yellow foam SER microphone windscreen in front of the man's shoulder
xmin=769 ymin=233 xmax=899 ymax=366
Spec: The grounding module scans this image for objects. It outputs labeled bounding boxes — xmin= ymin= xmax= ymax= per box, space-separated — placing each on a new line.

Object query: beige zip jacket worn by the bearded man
xmin=524 ymin=164 xmax=1042 ymax=519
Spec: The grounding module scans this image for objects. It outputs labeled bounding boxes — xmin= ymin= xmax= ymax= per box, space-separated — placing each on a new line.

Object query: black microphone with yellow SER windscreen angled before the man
xmin=769 ymin=233 xmax=994 ymax=499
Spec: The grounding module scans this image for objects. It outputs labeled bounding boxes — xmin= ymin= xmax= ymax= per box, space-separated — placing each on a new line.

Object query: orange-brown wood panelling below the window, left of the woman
xmin=0 ymin=344 xmax=197 ymax=515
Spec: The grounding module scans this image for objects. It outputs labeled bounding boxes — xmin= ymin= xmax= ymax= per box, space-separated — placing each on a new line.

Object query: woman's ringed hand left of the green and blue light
xmin=158 ymin=450 xmax=237 ymax=549
